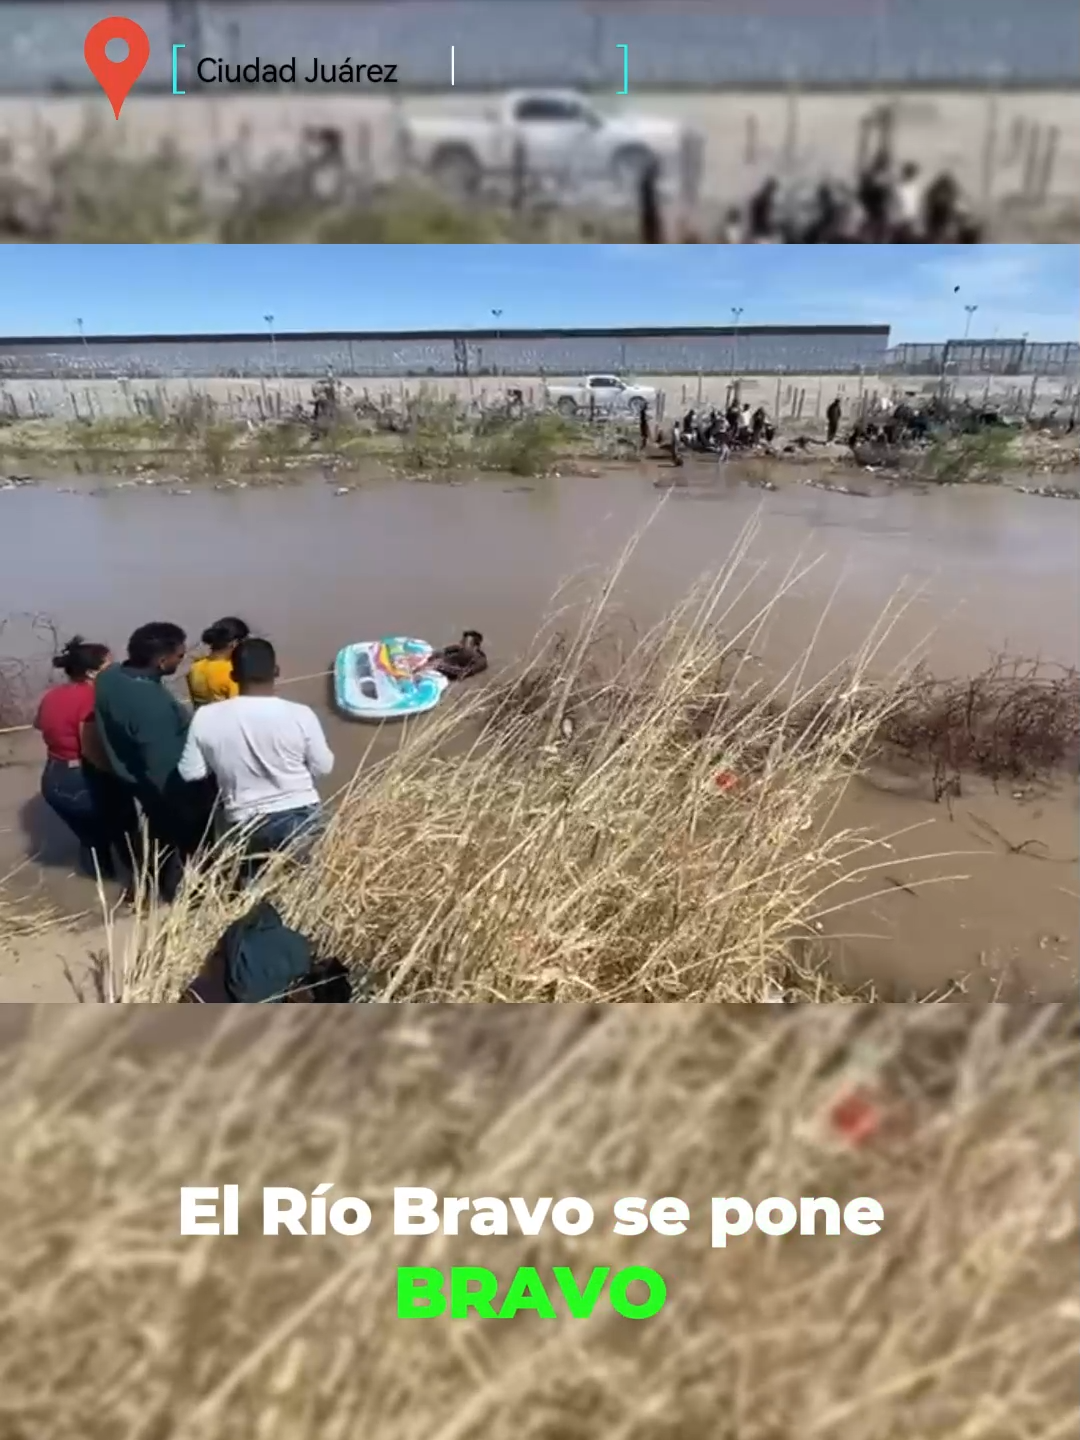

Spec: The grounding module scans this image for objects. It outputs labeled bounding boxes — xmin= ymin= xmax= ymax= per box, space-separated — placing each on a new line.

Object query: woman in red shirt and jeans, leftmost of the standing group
xmin=35 ymin=635 xmax=115 ymax=880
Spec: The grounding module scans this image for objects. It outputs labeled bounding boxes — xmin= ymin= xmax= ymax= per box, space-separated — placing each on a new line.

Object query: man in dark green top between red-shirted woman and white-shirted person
xmin=94 ymin=621 xmax=209 ymax=901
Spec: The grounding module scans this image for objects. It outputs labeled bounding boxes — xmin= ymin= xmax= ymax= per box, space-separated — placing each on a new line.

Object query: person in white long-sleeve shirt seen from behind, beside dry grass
xmin=179 ymin=639 xmax=334 ymax=857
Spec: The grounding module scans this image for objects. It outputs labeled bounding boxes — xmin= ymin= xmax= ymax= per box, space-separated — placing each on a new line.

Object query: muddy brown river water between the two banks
xmin=0 ymin=465 xmax=1080 ymax=994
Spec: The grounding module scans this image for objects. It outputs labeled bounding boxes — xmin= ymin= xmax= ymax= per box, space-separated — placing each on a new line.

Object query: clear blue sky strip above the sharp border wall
xmin=0 ymin=245 xmax=1080 ymax=343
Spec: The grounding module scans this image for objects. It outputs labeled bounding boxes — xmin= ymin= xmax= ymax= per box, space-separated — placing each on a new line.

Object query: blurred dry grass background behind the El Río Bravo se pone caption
xmin=0 ymin=1005 xmax=1080 ymax=1440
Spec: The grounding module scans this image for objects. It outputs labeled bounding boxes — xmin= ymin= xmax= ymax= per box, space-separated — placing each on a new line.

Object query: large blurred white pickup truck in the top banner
xmin=402 ymin=91 xmax=701 ymax=202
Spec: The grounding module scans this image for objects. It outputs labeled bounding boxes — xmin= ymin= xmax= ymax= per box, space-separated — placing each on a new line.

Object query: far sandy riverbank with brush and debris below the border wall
xmin=0 ymin=374 xmax=1080 ymax=498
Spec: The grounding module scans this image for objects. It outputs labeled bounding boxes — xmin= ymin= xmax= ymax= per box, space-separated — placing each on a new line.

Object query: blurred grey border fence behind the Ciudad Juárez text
xmin=0 ymin=0 xmax=1080 ymax=95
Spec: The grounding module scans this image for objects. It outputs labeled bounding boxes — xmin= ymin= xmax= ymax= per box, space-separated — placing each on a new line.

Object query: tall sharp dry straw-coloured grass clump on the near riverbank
xmin=102 ymin=537 xmax=956 ymax=1001
